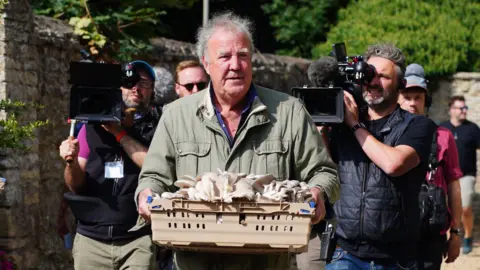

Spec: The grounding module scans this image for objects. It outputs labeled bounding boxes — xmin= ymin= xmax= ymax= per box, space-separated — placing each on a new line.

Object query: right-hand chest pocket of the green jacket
xmin=253 ymin=139 xmax=290 ymax=180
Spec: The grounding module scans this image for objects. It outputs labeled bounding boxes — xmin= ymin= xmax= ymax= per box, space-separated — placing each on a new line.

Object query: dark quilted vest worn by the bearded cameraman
xmin=332 ymin=107 xmax=427 ymax=260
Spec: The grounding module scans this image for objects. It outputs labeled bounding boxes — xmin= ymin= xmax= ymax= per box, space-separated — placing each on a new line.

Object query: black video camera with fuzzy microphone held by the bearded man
xmin=292 ymin=43 xmax=375 ymax=125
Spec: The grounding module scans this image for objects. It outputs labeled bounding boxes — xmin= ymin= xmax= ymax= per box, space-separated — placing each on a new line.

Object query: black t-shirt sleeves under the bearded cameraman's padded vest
xmin=365 ymin=115 xmax=437 ymax=165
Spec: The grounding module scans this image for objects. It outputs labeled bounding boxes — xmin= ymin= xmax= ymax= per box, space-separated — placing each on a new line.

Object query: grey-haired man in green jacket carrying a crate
xmin=135 ymin=13 xmax=339 ymax=269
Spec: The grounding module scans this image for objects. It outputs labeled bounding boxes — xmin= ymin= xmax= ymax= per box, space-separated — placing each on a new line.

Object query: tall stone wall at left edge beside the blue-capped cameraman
xmin=0 ymin=0 xmax=76 ymax=269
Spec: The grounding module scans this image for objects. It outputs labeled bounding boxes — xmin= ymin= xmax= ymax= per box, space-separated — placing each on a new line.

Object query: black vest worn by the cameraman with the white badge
xmin=66 ymin=106 xmax=160 ymax=240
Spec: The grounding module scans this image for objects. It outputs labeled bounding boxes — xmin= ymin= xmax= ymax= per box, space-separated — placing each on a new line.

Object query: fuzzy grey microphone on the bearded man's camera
xmin=308 ymin=56 xmax=339 ymax=87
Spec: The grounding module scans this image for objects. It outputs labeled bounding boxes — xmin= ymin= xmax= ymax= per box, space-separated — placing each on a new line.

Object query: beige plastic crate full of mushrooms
xmin=151 ymin=198 xmax=314 ymax=253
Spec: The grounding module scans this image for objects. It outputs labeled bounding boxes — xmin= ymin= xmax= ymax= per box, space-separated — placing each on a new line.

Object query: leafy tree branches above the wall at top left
xmin=31 ymin=0 xmax=198 ymax=61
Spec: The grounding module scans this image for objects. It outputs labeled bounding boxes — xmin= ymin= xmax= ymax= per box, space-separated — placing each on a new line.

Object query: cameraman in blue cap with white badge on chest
xmin=60 ymin=61 xmax=160 ymax=269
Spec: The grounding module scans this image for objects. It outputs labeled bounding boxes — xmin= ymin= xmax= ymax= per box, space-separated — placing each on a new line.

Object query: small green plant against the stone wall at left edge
xmin=0 ymin=100 xmax=48 ymax=150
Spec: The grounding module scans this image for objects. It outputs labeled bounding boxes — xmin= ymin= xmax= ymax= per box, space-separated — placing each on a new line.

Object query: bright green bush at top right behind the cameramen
xmin=313 ymin=0 xmax=480 ymax=76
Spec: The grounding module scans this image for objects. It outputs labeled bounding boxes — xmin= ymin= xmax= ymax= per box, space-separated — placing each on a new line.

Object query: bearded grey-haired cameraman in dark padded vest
xmin=326 ymin=44 xmax=436 ymax=269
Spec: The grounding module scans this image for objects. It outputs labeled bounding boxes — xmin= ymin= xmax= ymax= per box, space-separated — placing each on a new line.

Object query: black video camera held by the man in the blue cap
xmin=69 ymin=50 xmax=146 ymax=122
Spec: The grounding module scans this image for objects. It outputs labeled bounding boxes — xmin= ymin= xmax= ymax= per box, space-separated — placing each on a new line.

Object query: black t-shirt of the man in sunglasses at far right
xmin=440 ymin=120 xmax=480 ymax=176
